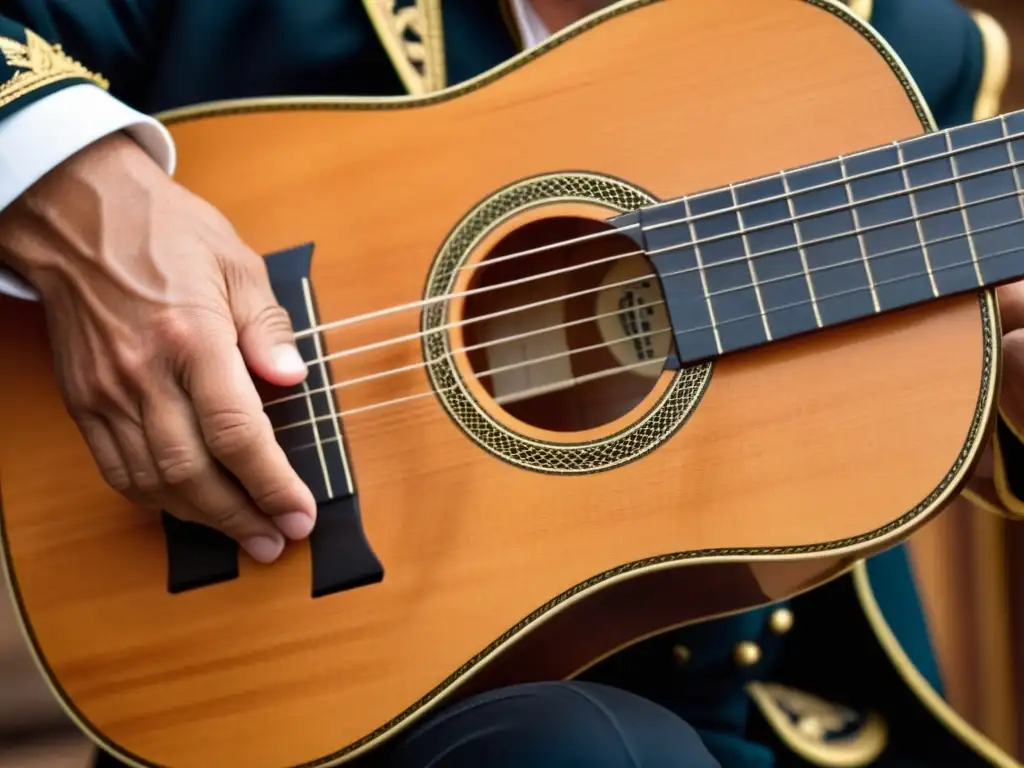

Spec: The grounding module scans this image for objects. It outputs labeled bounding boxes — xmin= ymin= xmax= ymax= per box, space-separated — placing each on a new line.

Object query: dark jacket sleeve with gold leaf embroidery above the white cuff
xmin=0 ymin=0 xmax=160 ymax=120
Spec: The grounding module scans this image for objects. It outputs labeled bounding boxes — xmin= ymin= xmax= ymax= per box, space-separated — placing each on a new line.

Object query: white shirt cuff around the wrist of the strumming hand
xmin=0 ymin=84 xmax=176 ymax=299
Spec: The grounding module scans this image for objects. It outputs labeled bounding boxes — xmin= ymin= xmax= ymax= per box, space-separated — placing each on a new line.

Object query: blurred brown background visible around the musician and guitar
xmin=6 ymin=0 xmax=1024 ymax=768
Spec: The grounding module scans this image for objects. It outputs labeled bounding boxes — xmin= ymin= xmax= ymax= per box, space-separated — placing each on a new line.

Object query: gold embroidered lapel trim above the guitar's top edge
xmin=362 ymin=0 xmax=447 ymax=96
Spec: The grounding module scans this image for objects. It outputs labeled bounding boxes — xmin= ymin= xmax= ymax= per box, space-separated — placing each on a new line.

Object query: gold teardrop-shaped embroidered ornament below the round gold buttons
xmin=746 ymin=682 xmax=889 ymax=768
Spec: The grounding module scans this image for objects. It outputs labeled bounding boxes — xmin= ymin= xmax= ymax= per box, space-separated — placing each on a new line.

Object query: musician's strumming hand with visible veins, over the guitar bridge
xmin=0 ymin=135 xmax=315 ymax=562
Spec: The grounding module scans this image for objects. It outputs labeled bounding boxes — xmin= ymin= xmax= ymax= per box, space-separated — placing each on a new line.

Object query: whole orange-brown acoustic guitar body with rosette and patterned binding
xmin=0 ymin=0 xmax=998 ymax=768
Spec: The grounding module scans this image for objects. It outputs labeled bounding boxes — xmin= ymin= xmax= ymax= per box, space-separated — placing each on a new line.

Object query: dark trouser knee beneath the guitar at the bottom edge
xmin=95 ymin=681 xmax=720 ymax=768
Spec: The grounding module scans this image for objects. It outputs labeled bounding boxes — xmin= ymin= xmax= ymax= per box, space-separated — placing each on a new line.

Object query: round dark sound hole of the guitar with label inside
xmin=463 ymin=216 xmax=672 ymax=432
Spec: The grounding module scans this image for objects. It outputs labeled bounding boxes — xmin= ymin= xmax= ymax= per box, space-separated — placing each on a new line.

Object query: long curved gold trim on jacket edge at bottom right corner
xmin=853 ymin=560 xmax=1024 ymax=768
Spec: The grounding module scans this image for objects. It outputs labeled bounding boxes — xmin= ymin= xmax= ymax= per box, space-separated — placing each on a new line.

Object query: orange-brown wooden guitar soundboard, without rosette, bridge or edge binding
xmin=0 ymin=0 xmax=995 ymax=768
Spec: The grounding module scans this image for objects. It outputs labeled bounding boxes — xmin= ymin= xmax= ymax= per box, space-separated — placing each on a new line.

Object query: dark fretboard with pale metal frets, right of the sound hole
xmin=623 ymin=105 xmax=1024 ymax=362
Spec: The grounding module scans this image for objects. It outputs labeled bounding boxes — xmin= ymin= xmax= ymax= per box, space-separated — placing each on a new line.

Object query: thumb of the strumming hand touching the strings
xmin=230 ymin=256 xmax=306 ymax=387
